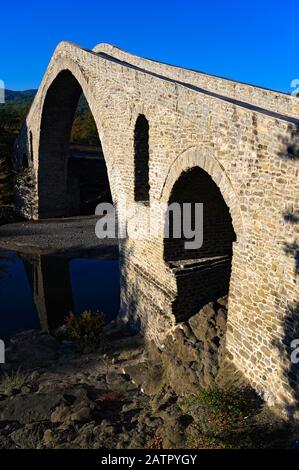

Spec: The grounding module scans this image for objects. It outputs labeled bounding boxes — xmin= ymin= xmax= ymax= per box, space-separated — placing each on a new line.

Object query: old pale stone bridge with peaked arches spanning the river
xmin=16 ymin=42 xmax=299 ymax=410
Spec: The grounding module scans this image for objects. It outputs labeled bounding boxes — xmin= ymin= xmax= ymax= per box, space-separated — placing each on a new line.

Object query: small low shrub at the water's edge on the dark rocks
xmin=65 ymin=310 xmax=105 ymax=347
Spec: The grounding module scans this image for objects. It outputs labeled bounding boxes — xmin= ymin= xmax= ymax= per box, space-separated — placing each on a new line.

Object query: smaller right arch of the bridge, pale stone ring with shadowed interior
xmin=160 ymin=148 xmax=243 ymax=321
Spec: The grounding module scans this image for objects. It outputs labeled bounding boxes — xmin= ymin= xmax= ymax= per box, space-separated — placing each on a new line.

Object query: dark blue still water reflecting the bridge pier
xmin=0 ymin=251 xmax=119 ymax=341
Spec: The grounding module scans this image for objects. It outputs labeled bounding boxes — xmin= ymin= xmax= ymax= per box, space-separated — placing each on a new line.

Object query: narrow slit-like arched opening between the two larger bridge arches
xmin=134 ymin=114 xmax=150 ymax=202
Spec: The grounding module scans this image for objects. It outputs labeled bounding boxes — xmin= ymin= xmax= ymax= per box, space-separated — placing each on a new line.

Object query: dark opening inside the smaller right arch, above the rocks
xmin=164 ymin=167 xmax=236 ymax=321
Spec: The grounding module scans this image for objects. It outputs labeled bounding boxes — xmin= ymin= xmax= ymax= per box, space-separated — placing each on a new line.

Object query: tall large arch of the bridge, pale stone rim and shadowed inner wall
xmin=35 ymin=58 xmax=114 ymax=217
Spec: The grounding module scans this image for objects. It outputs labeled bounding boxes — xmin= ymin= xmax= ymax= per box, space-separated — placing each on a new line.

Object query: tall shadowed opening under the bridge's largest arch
xmin=38 ymin=70 xmax=112 ymax=218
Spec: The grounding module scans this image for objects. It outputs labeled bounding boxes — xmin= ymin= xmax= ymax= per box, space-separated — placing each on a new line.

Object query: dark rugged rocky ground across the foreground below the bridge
xmin=0 ymin=318 xmax=299 ymax=449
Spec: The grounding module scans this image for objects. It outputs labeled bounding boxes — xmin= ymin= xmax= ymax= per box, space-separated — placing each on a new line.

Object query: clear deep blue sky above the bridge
xmin=0 ymin=0 xmax=299 ymax=92
